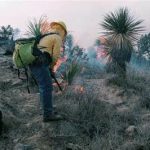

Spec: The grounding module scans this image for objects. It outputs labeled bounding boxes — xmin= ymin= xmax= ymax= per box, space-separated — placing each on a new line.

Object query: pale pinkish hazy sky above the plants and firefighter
xmin=0 ymin=0 xmax=150 ymax=48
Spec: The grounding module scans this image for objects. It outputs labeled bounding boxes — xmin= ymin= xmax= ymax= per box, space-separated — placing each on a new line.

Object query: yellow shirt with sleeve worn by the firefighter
xmin=38 ymin=34 xmax=62 ymax=68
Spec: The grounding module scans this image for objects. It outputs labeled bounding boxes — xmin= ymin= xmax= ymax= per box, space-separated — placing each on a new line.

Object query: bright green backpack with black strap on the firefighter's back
xmin=13 ymin=33 xmax=57 ymax=69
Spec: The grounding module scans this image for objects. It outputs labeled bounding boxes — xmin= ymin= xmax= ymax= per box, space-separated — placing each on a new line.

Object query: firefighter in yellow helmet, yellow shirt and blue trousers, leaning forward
xmin=30 ymin=21 xmax=67 ymax=122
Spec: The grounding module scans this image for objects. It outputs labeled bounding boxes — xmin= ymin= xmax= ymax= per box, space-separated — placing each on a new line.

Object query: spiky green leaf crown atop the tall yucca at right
xmin=101 ymin=8 xmax=143 ymax=40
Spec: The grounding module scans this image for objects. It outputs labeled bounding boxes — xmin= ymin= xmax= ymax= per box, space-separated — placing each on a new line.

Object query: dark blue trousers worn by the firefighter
xmin=30 ymin=64 xmax=53 ymax=117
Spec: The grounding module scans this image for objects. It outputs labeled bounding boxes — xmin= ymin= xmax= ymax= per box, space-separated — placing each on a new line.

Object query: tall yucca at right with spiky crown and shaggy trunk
xmin=101 ymin=8 xmax=143 ymax=76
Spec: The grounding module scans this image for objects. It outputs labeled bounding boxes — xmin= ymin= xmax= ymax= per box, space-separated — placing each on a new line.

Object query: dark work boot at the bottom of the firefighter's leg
xmin=43 ymin=113 xmax=64 ymax=122
